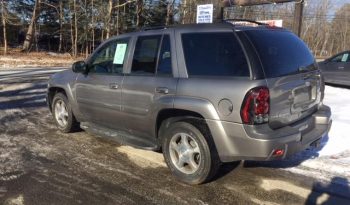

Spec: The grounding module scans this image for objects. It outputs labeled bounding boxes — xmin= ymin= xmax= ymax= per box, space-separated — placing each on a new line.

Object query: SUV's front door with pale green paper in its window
xmin=75 ymin=39 xmax=129 ymax=128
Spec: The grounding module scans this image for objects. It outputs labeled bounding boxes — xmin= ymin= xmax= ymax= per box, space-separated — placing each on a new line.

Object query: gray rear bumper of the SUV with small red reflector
xmin=207 ymin=105 xmax=332 ymax=162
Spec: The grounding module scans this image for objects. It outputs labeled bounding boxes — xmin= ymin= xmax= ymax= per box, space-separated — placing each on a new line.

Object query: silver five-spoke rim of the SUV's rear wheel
xmin=169 ymin=133 xmax=201 ymax=174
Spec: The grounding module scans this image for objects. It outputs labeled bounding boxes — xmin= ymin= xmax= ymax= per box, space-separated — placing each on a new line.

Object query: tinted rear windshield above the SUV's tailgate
xmin=246 ymin=30 xmax=316 ymax=78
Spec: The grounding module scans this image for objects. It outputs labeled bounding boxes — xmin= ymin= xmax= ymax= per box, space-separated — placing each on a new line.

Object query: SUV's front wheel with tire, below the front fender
xmin=52 ymin=93 xmax=79 ymax=133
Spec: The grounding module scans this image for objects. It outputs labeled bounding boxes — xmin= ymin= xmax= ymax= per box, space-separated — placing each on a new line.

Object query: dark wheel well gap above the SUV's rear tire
xmin=156 ymin=109 xmax=204 ymax=138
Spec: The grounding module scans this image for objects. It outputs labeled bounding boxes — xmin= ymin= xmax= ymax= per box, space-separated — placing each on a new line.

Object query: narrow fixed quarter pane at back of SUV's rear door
xmin=157 ymin=35 xmax=172 ymax=75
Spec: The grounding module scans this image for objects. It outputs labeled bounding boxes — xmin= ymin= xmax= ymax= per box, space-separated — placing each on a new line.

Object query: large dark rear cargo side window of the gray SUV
xmin=182 ymin=33 xmax=249 ymax=76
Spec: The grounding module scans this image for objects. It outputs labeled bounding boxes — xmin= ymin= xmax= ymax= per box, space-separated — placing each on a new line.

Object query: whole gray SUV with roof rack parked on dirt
xmin=47 ymin=23 xmax=331 ymax=184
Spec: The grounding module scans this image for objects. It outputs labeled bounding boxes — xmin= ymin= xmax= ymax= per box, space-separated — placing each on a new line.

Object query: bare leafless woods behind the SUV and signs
xmin=0 ymin=0 xmax=350 ymax=58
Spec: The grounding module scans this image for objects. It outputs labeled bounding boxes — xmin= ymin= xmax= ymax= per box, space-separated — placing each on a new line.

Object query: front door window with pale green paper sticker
xmin=89 ymin=39 xmax=128 ymax=74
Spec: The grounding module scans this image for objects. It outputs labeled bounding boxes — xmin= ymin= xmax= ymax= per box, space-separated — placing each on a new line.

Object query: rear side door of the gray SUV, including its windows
xmin=122 ymin=34 xmax=177 ymax=137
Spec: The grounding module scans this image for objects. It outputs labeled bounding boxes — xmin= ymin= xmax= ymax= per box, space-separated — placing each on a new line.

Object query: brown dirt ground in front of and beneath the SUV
xmin=0 ymin=69 xmax=350 ymax=205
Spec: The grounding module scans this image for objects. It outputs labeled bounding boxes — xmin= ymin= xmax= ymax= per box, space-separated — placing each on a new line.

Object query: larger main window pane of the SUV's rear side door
xmin=131 ymin=35 xmax=161 ymax=74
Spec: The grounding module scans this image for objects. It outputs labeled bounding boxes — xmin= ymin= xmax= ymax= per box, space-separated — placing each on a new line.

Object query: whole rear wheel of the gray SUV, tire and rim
xmin=162 ymin=122 xmax=221 ymax=184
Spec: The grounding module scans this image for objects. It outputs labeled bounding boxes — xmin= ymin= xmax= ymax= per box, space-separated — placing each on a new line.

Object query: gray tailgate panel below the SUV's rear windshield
xmin=267 ymin=71 xmax=321 ymax=129
